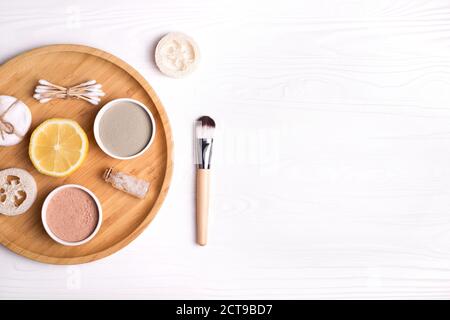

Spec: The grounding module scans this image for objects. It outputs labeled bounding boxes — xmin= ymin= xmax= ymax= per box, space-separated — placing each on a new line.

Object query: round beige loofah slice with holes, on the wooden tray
xmin=0 ymin=168 xmax=37 ymax=216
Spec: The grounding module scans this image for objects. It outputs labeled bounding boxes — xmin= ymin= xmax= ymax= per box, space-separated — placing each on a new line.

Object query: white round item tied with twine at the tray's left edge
xmin=0 ymin=96 xmax=31 ymax=146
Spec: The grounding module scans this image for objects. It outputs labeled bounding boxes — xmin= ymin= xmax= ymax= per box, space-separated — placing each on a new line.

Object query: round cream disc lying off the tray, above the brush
xmin=155 ymin=32 xmax=200 ymax=78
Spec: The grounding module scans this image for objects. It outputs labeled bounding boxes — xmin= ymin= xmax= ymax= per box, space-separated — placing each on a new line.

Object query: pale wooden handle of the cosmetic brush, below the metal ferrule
xmin=197 ymin=169 xmax=209 ymax=246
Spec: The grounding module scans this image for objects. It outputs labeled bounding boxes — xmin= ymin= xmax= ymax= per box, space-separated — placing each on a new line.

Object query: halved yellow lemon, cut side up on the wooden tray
xmin=28 ymin=119 xmax=89 ymax=177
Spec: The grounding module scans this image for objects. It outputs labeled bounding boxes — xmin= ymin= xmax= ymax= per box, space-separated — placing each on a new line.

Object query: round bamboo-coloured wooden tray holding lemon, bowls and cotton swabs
xmin=0 ymin=45 xmax=172 ymax=264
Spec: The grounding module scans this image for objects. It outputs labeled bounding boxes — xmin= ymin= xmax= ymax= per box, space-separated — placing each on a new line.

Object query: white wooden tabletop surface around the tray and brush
xmin=0 ymin=0 xmax=450 ymax=299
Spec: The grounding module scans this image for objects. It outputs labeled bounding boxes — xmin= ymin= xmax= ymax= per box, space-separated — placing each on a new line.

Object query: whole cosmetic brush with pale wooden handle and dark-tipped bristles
xmin=195 ymin=116 xmax=216 ymax=246
